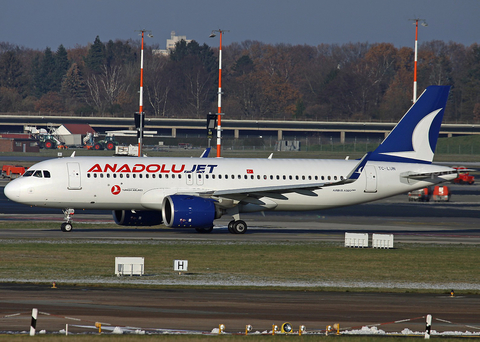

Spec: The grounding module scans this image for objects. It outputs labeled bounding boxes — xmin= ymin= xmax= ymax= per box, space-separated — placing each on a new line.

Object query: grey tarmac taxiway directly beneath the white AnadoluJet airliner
xmin=0 ymin=182 xmax=480 ymax=244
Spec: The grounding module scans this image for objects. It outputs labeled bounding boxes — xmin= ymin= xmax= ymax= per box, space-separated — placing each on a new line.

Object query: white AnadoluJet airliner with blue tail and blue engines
xmin=4 ymin=86 xmax=457 ymax=234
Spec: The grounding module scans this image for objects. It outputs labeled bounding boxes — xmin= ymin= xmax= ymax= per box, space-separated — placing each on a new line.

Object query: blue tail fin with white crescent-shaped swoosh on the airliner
xmin=370 ymin=86 xmax=450 ymax=163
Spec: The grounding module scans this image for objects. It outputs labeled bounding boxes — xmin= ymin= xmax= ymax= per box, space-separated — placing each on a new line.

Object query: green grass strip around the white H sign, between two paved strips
xmin=0 ymin=239 xmax=480 ymax=293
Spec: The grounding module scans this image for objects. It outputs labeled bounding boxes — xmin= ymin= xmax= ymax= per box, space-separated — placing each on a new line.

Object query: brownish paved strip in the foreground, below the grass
xmin=0 ymin=284 xmax=480 ymax=333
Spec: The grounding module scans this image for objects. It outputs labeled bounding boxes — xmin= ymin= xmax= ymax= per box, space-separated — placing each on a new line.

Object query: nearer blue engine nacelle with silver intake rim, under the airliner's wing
xmin=162 ymin=195 xmax=221 ymax=228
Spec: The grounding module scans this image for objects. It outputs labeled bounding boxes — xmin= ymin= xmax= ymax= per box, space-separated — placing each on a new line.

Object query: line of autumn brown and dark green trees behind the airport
xmin=0 ymin=36 xmax=480 ymax=123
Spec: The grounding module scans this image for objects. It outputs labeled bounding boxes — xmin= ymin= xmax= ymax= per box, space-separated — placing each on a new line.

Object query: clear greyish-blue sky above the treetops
xmin=0 ymin=0 xmax=480 ymax=50
